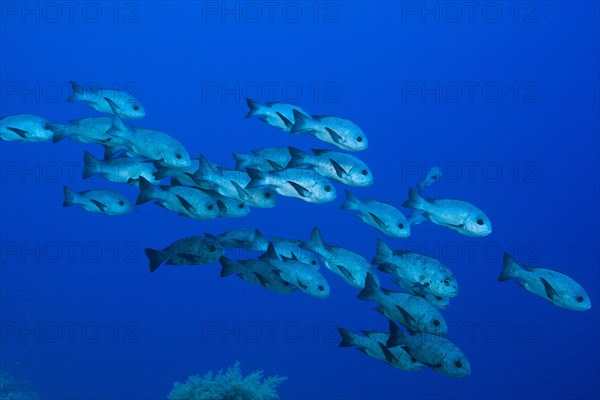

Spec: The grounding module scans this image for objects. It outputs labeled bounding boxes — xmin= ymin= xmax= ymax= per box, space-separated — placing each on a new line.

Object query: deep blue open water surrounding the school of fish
xmin=0 ymin=1 xmax=600 ymax=400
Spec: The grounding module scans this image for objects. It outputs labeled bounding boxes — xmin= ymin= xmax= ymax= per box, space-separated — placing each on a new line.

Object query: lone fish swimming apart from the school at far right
xmin=498 ymin=253 xmax=592 ymax=311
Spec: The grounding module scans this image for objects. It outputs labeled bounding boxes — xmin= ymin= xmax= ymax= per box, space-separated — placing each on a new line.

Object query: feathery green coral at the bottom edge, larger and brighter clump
xmin=168 ymin=361 xmax=287 ymax=400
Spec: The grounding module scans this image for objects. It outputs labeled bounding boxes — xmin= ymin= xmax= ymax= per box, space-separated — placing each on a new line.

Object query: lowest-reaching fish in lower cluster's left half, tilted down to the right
xmin=259 ymin=243 xmax=330 ymax=299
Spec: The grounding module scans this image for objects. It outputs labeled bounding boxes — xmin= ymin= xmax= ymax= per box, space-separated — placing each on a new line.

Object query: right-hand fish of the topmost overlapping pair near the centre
xmin=290 ymin=110 xmax=369 ymax=151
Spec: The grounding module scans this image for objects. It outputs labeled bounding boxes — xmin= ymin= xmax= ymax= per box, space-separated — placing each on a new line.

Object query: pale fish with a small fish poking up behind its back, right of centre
xmin=402 ymin=188 xmax=492 ymax=237
